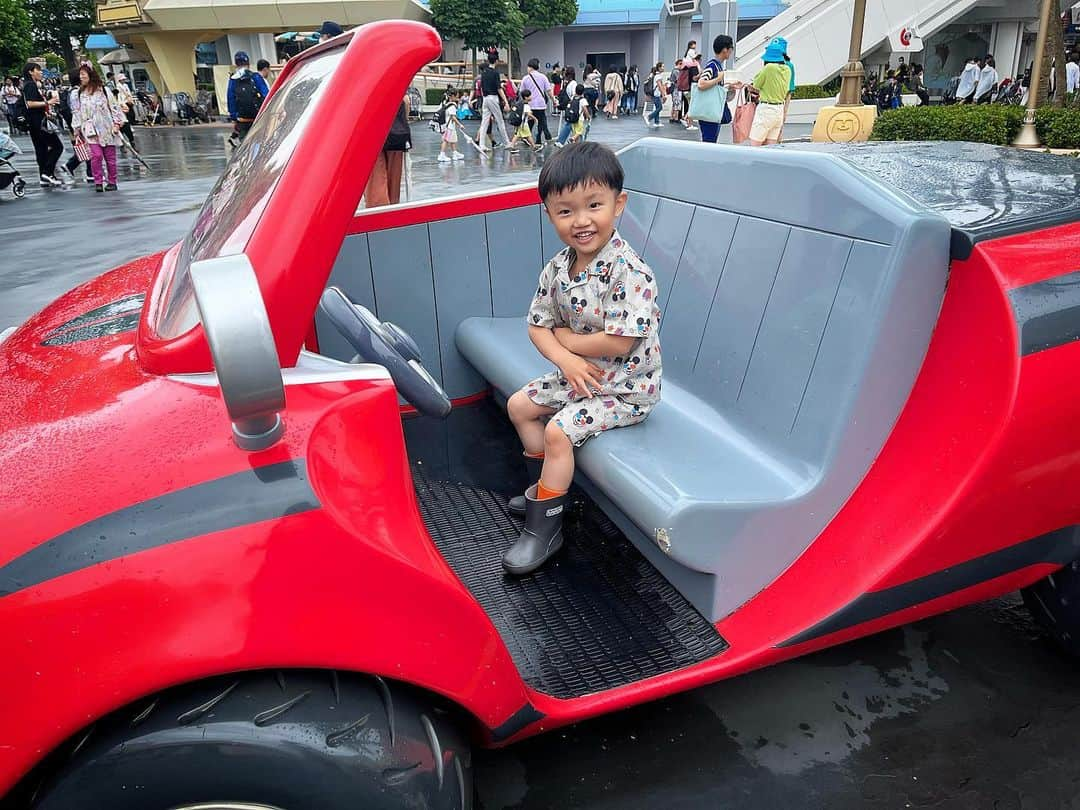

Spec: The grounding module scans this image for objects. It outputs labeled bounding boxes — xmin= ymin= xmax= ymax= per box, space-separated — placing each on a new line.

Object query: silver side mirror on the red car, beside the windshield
xmin=191 ymin=254 xmax=285 ymax=450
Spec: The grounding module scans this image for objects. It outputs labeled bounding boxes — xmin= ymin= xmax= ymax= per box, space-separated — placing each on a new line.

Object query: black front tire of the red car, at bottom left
xmin=31 ymin=671 xmax=473 ymax=810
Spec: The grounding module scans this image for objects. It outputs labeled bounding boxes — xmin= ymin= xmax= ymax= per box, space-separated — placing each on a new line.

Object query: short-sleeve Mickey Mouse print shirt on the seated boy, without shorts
xmin=527 ymin=231 xmax=661 ymax=406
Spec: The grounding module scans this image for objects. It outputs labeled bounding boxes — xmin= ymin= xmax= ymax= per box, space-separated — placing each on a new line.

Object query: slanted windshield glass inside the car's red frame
xmin=154 ymin=48 xmax=345 ymax=338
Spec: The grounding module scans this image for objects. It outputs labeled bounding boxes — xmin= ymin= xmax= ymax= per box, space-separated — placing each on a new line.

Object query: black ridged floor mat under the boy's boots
xmin=414 ymin=465 xmax=727 ymax=698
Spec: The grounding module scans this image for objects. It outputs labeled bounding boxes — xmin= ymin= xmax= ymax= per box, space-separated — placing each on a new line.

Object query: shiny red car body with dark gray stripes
xmin=0 ymin=17 xmax=1080 ymax=795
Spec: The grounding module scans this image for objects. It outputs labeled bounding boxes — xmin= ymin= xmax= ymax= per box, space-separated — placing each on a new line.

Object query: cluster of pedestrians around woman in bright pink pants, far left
xmin=2 ymin=62 xmax=145 ymax=192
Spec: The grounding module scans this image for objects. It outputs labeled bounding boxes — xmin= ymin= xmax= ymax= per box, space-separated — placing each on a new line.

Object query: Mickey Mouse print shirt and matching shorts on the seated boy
xmin=524 ymin=231 xmax=661 ymax=445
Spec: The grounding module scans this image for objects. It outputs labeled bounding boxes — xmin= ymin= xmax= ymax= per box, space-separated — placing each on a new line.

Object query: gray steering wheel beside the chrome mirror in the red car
xmin=319 ymin=287 xmax=450 ymax=419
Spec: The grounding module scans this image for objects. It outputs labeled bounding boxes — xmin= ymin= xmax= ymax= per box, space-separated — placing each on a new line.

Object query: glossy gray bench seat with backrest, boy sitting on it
xmin=455 ymin=138 xmax=949 ymax=619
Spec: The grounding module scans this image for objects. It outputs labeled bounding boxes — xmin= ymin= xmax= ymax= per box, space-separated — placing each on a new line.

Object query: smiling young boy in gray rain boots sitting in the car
xmin=502 ymin=145 xmax=661 ymax=576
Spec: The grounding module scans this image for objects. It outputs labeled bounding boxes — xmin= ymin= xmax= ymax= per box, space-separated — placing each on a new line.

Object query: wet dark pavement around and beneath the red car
xmin=0 ymin=120 xmax=1080 ymax=810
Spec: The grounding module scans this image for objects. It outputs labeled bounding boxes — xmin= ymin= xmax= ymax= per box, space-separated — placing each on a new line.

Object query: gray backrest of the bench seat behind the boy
xmin=619 ymin=138 xmax=949 ymax=469
